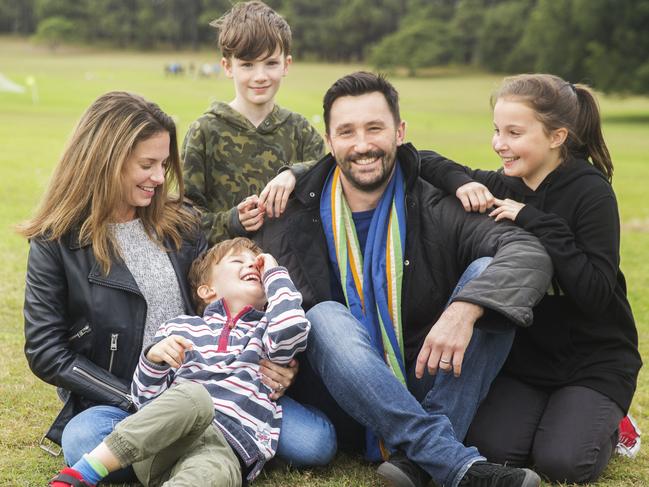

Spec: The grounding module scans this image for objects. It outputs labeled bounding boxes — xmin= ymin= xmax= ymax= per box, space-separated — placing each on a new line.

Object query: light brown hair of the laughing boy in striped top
xmin=187 ymin=237 xmax=263 ymax=315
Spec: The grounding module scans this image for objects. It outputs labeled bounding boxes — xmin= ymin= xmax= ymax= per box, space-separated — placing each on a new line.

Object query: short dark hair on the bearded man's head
xmin=322 ymin=71 xmax=401 ymax=133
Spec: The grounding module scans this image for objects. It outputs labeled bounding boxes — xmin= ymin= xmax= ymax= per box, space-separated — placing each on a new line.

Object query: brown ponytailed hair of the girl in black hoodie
xmin=491 ymin=74 xmax=613 ymax=182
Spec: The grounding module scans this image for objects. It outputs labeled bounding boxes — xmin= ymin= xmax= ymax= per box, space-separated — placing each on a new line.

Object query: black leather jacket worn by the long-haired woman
xmin=24 ymin=227 xmax=206 ymax=444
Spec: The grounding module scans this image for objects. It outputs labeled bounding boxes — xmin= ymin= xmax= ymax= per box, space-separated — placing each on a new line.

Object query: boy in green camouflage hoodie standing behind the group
xmin=182 ymin=1 xmax=325 ymax=244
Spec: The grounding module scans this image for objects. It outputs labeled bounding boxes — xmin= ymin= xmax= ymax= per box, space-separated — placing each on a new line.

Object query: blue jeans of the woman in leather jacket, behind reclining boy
xmin=61 ymin=396 xmax=336 ymax=476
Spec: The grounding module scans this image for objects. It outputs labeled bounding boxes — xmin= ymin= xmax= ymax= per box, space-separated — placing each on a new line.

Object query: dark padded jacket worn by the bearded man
xmin=256 ymin=144 xmax=552 ymax=365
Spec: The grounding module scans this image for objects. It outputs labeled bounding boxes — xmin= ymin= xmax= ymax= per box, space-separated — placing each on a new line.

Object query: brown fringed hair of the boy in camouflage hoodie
xmin=210 ymin=1 xmax=291 ymax=61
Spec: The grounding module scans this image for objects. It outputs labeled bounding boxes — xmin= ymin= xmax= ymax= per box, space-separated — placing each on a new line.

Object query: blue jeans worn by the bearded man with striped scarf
xmin=307 ymin=261 xmax=514 ymax=487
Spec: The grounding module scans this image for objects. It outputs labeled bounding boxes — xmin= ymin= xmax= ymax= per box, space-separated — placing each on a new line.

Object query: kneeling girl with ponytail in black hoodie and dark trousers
xmin=423 ymin=74 xmax=642 ymax=483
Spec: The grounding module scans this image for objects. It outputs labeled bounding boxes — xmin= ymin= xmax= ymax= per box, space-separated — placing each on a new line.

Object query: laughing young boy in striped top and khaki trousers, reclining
xmin=49 ymin=238 xmax=310 ymax=487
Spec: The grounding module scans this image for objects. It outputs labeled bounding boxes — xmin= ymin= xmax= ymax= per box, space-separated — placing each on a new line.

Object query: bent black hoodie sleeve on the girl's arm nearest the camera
xmin=516 ymin=190 xmax=620 ymax=316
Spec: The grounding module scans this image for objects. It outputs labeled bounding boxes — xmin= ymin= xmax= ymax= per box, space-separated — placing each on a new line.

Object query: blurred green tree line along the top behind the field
xmin=0 ymin=0 xmax=649 ymax=94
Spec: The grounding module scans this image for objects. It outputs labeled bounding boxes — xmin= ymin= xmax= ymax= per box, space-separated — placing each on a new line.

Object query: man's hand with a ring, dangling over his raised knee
xmin=415 ymin=301 xmax=484 ymax=379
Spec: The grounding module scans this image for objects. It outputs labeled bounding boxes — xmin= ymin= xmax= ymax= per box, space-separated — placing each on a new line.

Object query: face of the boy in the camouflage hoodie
xmin=221 ymin=47 xmax=292 ymax=113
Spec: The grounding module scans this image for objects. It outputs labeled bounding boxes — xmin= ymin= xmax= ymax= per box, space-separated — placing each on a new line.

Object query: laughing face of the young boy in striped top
xmin=198 ymin=249 xmax=266 ymax=314
